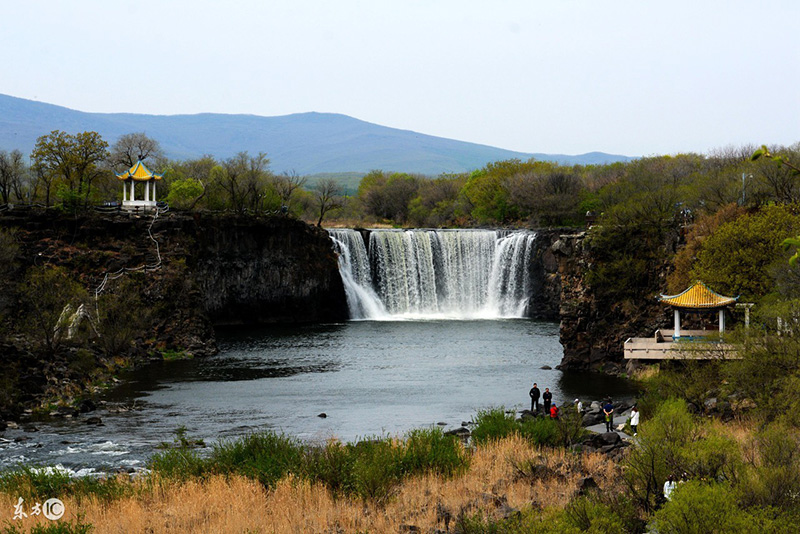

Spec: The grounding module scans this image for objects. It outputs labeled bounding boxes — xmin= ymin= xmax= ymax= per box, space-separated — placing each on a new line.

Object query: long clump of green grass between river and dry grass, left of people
xmin=150 ymin=429 xmax=468 ymax=500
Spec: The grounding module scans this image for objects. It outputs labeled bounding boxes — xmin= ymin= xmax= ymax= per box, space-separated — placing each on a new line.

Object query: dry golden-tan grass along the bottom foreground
xmin=0 ymin=437 xmax=619 ymax=534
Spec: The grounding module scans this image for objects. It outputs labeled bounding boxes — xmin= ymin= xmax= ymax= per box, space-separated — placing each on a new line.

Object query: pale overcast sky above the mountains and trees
xmin=0 ymin=0 xmax=800 ymax=156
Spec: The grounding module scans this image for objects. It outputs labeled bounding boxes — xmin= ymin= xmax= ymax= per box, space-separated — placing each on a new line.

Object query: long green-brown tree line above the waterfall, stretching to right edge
xmin=339 ymin=145 xmax=800 ymax=227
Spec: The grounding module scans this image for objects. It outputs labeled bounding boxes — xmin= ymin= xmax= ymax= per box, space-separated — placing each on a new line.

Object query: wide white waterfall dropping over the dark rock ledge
xmin=330 ymin=230 xmax=536 ymax=320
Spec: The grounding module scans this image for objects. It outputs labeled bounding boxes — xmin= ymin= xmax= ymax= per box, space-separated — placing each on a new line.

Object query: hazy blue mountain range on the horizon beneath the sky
xmin=0 ymin=94 xmax=633 ymax=175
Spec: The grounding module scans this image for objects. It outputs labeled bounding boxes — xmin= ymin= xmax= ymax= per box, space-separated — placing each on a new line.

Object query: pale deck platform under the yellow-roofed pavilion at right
xmin=624 ymin=330 xmax=739 ymax=360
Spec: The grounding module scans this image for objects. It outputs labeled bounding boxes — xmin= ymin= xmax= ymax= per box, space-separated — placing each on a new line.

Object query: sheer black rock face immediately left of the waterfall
xmin=187 ymin=217 xmax=347 ymax=324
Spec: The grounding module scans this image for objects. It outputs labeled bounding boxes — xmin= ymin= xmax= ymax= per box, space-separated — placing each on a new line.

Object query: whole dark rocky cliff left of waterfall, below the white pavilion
xmin=0 ymin=210 xmax=347 ymax=420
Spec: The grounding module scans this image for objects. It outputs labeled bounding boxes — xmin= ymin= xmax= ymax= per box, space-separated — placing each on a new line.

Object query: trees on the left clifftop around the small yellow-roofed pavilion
xmin=0 ymin=130 xmax=341 ymax=224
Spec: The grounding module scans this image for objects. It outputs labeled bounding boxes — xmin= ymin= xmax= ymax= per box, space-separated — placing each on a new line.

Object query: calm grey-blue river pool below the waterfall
xmin=0 ymin=319 xmax=633 ymax=473
